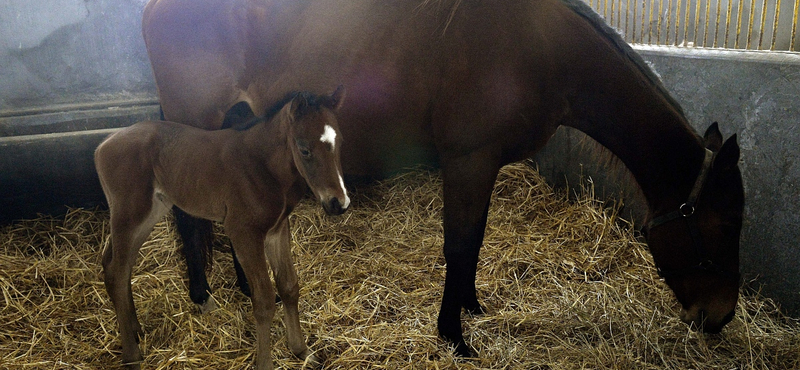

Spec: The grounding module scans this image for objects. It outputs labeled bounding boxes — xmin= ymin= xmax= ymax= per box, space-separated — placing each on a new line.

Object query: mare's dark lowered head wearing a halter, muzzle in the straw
xmin=645 ymin=123 xmax=744 ymax=333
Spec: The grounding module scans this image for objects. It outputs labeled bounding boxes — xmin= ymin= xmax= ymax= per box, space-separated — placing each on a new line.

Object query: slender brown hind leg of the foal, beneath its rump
xmin=103 ymin=199 xmax=169 ymax=369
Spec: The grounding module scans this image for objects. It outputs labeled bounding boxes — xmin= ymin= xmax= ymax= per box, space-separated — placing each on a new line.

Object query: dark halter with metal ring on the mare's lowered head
xmin=647 ymin=149 xmax=740 ymax=280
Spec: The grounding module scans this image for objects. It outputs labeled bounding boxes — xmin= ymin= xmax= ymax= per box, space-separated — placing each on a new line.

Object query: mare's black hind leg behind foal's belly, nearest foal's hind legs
xmin=173 ymin=207 xmax=216 ymax=313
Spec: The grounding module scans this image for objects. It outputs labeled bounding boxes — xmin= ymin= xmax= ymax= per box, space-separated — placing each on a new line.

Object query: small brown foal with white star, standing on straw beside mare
xmin=95 ymin=87 xmax=350 ymax=369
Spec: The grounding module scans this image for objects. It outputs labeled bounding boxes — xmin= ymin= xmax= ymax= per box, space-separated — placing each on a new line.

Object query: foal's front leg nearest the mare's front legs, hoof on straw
xmin=265 ymin=218 xmax=320 ymax=365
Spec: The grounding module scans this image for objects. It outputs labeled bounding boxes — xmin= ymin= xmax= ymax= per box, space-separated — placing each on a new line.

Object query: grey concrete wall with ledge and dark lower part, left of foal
xmin=0 ymin=0 xmax=158 ymax=223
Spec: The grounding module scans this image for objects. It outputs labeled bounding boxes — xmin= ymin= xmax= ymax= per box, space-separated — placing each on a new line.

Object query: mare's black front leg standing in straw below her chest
xmin=438 ymin=150 xmax=500 ymax=357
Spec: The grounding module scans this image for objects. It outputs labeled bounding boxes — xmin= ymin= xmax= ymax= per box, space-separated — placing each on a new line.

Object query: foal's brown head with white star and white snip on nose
xmin=283 ymin=86 xmax=350 ymax=215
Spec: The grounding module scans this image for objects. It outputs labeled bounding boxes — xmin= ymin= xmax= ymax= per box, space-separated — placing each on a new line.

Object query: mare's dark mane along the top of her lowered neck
xmin=561 ymin=0 xmax=687 ymax=121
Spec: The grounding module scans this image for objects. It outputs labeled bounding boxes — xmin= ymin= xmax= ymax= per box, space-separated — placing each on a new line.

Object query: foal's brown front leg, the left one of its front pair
xmin=225 ymin=220 xmax=275 ymax=370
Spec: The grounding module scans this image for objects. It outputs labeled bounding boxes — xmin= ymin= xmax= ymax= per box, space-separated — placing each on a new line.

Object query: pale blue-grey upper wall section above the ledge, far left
xmin=0 ymin=0 xmax=154 ymax=112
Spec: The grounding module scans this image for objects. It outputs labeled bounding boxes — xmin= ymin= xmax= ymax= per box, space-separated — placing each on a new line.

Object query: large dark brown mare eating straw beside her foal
xmin=143 ymin=0 xmax=744 ymax=356
